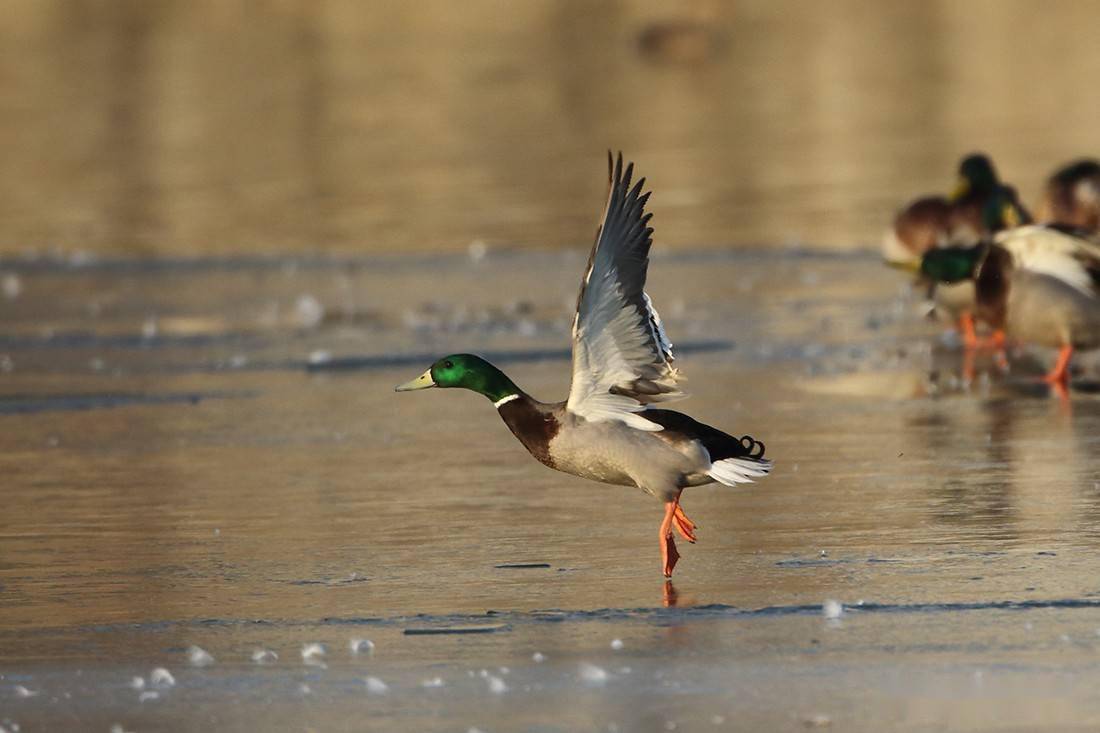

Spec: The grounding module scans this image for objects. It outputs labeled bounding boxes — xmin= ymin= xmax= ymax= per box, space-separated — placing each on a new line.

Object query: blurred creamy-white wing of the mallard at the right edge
xmin=993 ymin=226 xmax=1100 ymax=297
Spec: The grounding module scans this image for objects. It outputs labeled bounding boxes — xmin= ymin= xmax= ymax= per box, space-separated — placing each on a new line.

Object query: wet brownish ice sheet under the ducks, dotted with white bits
xmin=0 ymin=251 xmax=1100 ymax=731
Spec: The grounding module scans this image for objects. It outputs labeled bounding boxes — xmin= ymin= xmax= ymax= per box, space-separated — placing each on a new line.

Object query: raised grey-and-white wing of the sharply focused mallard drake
xmin=565 ymin=153 xmax=686 ymax=430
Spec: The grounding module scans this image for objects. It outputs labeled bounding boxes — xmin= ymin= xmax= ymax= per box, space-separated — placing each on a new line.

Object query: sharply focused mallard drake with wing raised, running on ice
xmin=396 ymin=154 xmax=771 ymax=578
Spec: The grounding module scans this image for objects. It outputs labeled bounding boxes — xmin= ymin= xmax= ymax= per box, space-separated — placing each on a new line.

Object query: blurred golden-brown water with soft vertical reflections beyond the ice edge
xmin=0 ymin=0 xmax=1100 ymax=255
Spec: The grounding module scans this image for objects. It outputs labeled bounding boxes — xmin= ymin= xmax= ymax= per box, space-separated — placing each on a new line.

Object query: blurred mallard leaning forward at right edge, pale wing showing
xmin=921 ymin=225 xmax=1100 ymax=394
